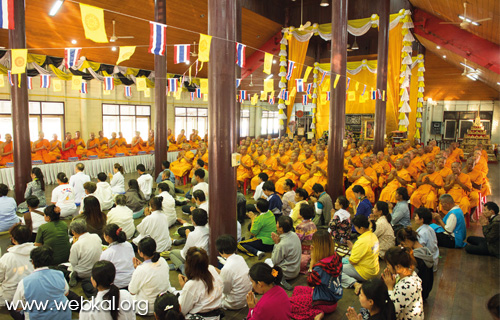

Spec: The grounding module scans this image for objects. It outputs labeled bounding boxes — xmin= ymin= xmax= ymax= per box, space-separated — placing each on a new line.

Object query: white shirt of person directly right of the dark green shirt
xmin=69 ymin=232 xmax=102 ymax=278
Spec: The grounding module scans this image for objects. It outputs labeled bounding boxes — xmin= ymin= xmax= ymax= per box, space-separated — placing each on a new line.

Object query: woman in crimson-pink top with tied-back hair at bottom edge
xmin=247 ymin=262 xmax=292 ymax=320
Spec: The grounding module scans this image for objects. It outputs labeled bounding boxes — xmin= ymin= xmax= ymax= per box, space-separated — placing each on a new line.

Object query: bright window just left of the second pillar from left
xmin=102 ymin=104 xmax=151 ymax=142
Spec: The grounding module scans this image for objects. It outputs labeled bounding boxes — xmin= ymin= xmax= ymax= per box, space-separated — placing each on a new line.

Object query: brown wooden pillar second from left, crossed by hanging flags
xmin=155 ymin=0 xmax=167 ymax=177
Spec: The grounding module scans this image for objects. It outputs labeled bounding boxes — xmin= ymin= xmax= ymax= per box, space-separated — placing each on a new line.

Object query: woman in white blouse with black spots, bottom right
xmin=382 ymin=247 xmax=424 ymax=320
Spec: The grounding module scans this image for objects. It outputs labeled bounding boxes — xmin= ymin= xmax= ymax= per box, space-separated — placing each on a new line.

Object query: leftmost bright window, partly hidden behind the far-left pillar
xmin=0 ymin=100 xmax=64 ymax=141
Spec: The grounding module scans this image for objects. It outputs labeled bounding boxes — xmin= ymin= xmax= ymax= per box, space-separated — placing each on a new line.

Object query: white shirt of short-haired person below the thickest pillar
xmin=220 ymin=254 xmax=252 ymax=310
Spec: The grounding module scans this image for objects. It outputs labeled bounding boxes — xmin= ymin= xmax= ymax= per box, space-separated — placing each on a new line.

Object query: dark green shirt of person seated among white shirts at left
xmin=35 ymin=221 xmax=71 ymax=265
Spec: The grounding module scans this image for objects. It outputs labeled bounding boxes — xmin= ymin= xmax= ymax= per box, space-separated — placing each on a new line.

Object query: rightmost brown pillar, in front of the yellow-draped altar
xmin=373 ymin=0 xmax=390 ymax=153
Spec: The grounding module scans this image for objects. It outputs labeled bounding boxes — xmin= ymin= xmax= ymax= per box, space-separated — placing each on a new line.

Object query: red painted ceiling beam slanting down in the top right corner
xmin=413 ymin=9 xmax=500 ymax=74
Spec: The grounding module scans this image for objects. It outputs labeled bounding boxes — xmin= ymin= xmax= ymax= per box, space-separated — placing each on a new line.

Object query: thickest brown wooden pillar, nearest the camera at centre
xmin=208 ymin=0 xmax=239 ymax=264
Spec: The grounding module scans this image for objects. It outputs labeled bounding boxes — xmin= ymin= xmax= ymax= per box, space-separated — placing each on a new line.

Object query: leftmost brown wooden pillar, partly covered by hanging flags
xmin=9 ymin=0 xmax=31 ymax=203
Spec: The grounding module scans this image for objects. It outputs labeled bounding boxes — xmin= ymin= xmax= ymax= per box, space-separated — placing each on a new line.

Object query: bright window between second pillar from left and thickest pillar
xmin=175 ymin=107 xmax=208 ymax=139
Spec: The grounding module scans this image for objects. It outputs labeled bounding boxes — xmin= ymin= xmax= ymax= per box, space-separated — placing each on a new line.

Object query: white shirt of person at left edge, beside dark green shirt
xmin=0 ymin=242 xmax=36 ymax=307
